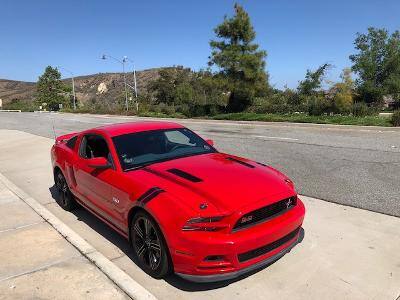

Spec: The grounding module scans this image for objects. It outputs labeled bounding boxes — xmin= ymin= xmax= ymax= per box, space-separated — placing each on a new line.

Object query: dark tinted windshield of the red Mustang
xmin=113 ymin=128 xmax=216 ymax=171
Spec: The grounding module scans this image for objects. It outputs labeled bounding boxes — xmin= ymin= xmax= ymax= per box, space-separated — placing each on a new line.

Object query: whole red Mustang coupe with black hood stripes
xmin=51 ymin=122 xmax=305 ymax=282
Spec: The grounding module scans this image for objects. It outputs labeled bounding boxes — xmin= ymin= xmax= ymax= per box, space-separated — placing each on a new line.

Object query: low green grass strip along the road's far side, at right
xmin=212 ymin=113 xmax=392 ymax=126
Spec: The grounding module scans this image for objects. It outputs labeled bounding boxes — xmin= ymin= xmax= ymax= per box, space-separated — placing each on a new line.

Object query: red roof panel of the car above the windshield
xmin=95 ymin=121 xmax=184 ymax=137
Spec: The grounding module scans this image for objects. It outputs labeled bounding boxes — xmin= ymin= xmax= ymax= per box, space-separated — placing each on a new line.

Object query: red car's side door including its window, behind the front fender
xmin=74 ymin=133 xmax=116 ymax=223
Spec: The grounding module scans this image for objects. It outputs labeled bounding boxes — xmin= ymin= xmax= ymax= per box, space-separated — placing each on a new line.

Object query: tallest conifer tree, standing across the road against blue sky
xmin=209 ymin=4 xmax=268 ymax=112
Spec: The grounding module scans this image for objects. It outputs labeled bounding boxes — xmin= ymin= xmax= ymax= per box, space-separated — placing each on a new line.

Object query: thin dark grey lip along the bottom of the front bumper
xmin=176 ymin=228 xmax=304 ymax=283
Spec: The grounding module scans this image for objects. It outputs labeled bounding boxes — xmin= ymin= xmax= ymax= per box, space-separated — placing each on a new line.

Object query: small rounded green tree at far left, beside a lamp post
xmin=36 ymin=66 xmax=69 ymax=110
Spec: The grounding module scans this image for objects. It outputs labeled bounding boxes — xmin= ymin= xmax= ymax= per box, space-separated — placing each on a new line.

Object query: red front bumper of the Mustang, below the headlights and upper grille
xmin=171 ymin=199 xmax=305 ymax=282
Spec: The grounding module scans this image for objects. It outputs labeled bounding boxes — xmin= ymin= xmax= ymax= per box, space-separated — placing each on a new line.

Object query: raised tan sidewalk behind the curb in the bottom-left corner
xmin=0 ymin=182 xmax=128 ymax=299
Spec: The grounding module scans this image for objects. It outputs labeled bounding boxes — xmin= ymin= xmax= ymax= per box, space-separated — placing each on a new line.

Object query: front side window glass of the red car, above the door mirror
xmin=79 ymin=134 xmax=112 ymax=163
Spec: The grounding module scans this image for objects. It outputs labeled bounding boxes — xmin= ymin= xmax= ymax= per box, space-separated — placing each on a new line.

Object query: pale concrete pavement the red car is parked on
xmin=0 ymin=130 xmax=400 ymax=300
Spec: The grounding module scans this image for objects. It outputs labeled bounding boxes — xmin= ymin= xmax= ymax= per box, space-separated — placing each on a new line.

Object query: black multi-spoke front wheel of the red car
xmin=131 ymin=211 xmax=171 ymax=279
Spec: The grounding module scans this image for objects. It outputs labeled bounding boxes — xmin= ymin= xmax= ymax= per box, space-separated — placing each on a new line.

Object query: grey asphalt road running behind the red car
xmin=0 ymin=113 xmax=400 ymax=217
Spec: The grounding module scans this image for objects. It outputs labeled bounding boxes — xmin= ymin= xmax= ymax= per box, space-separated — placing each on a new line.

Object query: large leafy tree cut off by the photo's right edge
xmin=350 ymin=27 xmax=400 ymax=103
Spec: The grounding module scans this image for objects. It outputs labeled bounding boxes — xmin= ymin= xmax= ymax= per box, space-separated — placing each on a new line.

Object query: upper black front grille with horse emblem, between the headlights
xmin=233 ymin=196 xmax=297 ymax=231
